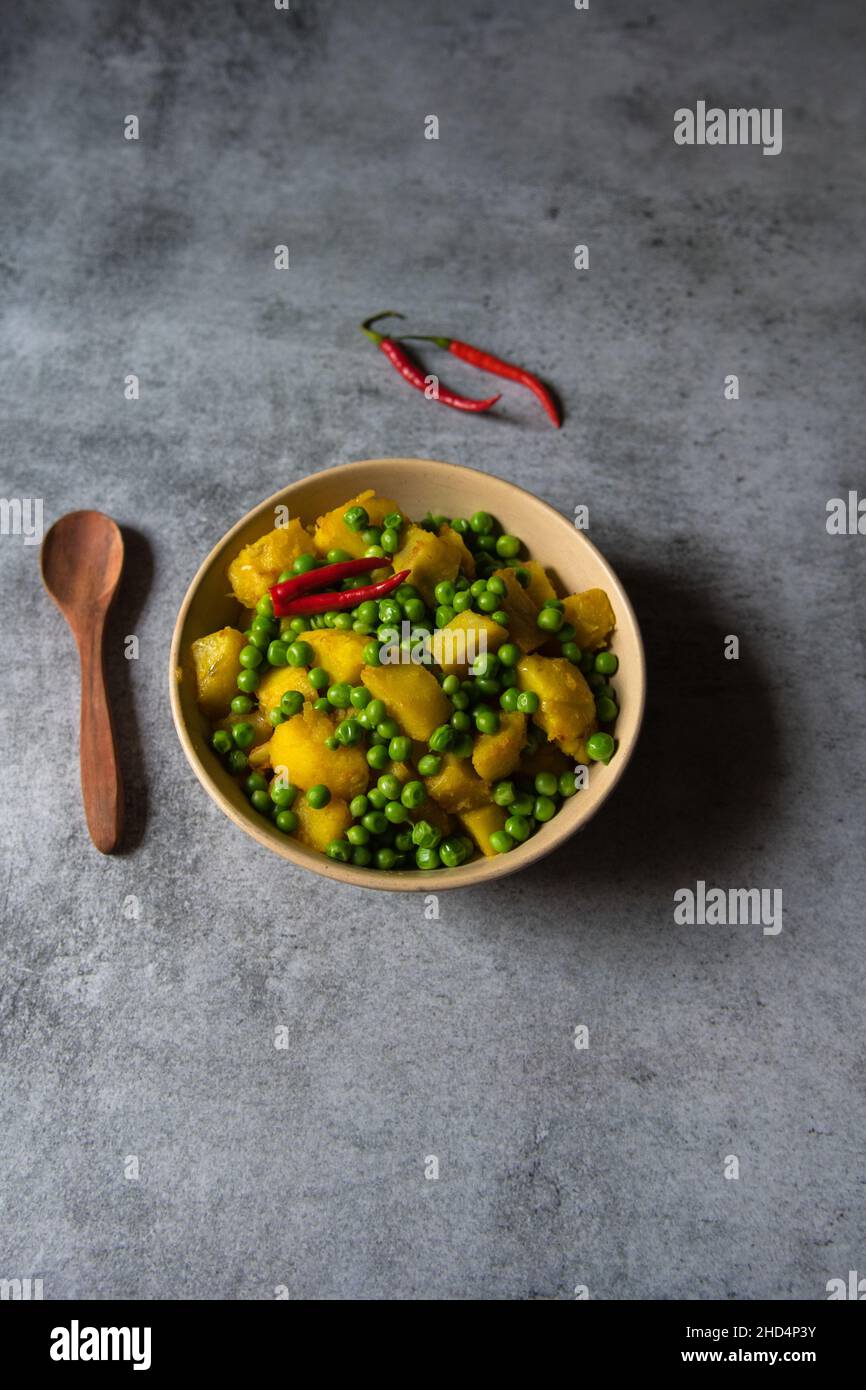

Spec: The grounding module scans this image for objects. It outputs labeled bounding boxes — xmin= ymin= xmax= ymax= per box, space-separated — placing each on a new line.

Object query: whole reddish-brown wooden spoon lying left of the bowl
xmin=42 ymin=512 xmax=124 ymax=855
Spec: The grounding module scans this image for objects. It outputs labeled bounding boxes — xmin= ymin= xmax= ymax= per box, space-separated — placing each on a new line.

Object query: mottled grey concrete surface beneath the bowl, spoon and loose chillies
xmin=0 ymin=0 xmax=866 ymax=1300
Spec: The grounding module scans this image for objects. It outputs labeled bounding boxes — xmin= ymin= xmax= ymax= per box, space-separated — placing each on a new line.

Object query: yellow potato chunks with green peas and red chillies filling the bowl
xmin=189 ymin=491 xmax=619 ymax=870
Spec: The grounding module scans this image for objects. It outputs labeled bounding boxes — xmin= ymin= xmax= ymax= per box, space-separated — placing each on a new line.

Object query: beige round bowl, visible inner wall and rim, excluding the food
xmin=170 ymin=459 xmax=646 ymax=892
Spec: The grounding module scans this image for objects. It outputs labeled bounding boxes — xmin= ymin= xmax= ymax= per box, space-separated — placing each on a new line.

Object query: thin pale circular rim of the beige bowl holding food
xmin=168 ymin=456 xmax=646 ymax=895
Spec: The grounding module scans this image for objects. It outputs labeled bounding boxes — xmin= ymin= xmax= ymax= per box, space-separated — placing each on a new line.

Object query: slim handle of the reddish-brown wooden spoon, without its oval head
xmin=78 ymin=613 xmax=124 ymax=855
